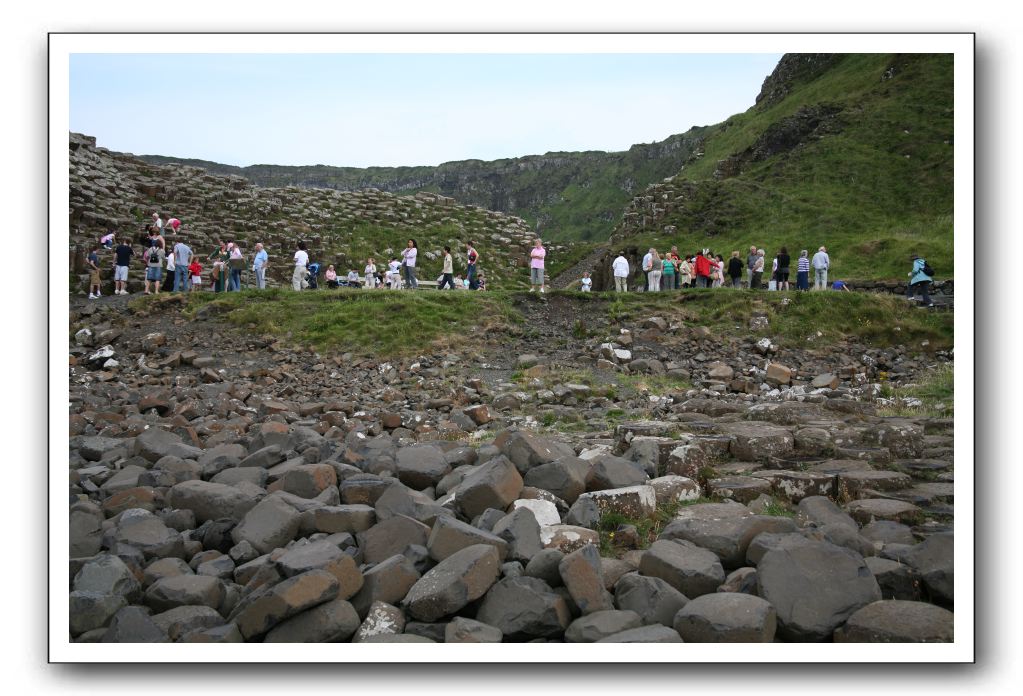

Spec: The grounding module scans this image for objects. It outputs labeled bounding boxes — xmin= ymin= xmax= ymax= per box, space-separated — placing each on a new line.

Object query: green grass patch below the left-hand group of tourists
xmin=179 ymin=290 xmax=522 ymax=357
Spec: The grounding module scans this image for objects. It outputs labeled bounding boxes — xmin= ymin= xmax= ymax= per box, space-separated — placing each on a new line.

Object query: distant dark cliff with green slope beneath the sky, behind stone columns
xmin=139 ymin=128 xmax=704 ymax=240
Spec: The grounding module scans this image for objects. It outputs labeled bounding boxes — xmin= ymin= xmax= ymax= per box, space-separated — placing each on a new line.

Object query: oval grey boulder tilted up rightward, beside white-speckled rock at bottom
xmin=404 ymin=545 xmax=500 ymax=621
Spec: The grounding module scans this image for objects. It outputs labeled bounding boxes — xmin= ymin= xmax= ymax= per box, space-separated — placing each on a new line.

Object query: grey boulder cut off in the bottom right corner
xmin=835 ymin=600 xmax=955 ymax=643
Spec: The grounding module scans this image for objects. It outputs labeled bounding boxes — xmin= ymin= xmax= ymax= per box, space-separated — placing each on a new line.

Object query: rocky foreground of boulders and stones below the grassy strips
xmin=69 ymin=296 xmax=954 ymax=643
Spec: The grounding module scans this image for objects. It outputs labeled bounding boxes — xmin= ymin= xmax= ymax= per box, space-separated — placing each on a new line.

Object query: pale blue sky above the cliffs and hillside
xmin=70 ymin=53 xmax=782 ymax=167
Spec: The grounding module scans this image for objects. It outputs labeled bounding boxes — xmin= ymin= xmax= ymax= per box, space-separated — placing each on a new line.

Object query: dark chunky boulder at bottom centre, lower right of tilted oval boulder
xmin=476 ymin=576 xmax=571 ymax=641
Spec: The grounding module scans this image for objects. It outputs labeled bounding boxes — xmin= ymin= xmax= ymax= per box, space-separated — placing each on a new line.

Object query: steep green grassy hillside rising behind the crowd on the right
xmin=614 ymin=54 xmax=954 ymax=278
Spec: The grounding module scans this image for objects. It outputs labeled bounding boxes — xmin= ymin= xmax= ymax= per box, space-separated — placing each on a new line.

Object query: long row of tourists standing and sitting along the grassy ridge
xmin=86 ymin=213 xmax=934 ymax=306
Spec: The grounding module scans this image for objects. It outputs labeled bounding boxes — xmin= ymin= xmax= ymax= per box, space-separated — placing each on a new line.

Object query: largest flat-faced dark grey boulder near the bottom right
xmin=757 ymin=541 xmax=881 ymax=642
